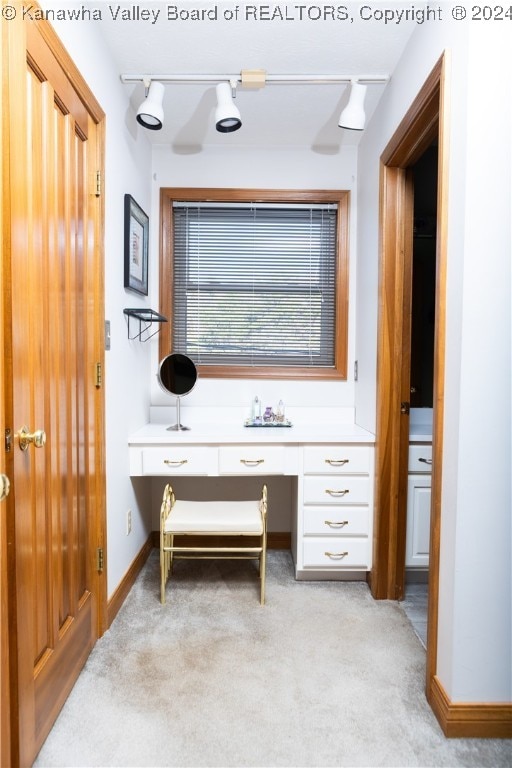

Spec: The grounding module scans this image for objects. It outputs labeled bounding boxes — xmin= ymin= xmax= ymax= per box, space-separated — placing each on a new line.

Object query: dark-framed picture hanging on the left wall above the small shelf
xmin=124 ymin=195 xmax=149 ymax=296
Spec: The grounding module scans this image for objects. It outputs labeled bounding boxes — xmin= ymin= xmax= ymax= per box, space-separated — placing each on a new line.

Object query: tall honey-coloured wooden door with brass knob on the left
xmin=2 ymin=13 xmax=104 ymax=765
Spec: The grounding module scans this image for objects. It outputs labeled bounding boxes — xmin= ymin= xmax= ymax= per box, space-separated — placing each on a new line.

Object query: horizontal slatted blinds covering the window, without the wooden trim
xmin=172 ymin=202 xmax=337 ymax=368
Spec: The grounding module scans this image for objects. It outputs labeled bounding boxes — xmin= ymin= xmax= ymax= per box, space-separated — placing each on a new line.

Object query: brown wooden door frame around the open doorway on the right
xmin=370 ymin=51 xmax=449 ymax=700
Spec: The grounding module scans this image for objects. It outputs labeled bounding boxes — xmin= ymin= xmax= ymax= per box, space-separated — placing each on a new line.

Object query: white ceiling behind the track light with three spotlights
xmin=100 ymin=0 xmax=414 ymax=154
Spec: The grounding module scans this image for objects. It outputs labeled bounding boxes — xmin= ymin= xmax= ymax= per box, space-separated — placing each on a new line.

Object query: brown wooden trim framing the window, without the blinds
xmin=159 ymin=187 xmax=350 ymax=380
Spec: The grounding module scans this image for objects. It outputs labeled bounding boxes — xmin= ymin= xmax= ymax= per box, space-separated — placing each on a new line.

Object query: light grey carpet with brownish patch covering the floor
xmin=35 ymin=551 xmax=512 ymax=768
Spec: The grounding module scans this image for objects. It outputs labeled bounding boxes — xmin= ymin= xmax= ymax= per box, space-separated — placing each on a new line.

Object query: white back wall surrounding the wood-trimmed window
xmin=151 ymin=146 xmax=356 ymax=412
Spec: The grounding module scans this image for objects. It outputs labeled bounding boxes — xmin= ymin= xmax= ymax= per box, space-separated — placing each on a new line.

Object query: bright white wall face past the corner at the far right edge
xmin=446 ymin=27 xmax=512 ymax=701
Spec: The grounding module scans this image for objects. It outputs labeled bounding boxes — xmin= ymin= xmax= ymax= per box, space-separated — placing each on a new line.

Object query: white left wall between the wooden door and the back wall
xmin=45 ymin=13 xmax=157 ymax=596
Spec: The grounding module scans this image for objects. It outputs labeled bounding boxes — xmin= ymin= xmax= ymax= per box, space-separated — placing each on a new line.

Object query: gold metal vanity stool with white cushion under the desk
xmin=160 ymin=484 xmax=267 ymax=605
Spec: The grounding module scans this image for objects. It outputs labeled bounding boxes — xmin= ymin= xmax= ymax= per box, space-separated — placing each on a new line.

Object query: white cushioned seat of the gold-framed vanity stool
xmin=164 ymin=500 xmax=263 ymax=535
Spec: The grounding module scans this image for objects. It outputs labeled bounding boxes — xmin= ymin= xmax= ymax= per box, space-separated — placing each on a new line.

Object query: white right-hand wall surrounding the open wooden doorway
xmin=356 ymin=22 xmax=512 ymax=702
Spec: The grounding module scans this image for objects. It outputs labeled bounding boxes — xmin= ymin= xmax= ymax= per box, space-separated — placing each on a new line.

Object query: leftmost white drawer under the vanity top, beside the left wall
xmin=142 ymin=445 xmax=217 ymax=476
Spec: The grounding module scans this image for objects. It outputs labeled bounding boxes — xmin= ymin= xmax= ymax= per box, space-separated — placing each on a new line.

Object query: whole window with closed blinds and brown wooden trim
xmin=161 ymin=189 xmax=348 ymax=378
